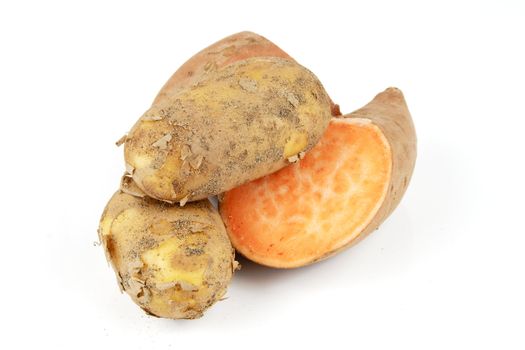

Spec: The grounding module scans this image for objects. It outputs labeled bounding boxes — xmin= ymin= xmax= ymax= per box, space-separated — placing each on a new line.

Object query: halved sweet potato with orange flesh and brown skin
xmin=220 ymin=88 xmax=416 ymax=268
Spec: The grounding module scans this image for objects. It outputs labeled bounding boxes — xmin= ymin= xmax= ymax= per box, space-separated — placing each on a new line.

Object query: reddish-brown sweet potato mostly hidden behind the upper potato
xmin=153 ymin=32 xmax=341 ymax=116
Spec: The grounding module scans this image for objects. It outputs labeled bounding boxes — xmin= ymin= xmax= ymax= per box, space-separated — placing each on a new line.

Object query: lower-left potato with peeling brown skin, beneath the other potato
xmin=99 ymin=191 xmax=236 ymax=319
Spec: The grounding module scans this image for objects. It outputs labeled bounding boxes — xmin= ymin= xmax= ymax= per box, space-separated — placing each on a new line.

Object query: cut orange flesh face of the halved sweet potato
xmin=221 ymin=119 xmax=391 ymax=266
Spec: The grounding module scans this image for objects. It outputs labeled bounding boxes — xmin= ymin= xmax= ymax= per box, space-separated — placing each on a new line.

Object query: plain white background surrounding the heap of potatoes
xmin=0 ymin=0 xmax=525 ymax=349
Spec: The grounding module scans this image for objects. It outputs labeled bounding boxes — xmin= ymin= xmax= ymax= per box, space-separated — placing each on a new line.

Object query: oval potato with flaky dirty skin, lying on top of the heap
xmin=124 ymin=57 xmax=331 ymax=204
